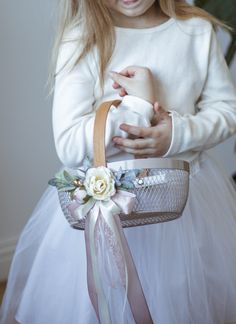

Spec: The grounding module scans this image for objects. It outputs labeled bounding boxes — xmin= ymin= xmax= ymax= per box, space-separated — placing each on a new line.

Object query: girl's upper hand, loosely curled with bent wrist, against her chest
xmin=110 ymin=66 xmax=156 ymax=104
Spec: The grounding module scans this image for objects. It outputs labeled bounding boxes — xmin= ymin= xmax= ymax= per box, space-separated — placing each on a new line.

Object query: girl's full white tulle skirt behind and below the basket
xmin=0 ymin=154 xmax=236 ymax=324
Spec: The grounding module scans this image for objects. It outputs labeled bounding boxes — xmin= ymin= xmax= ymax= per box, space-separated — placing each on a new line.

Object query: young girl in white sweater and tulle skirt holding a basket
xmin=0 ymin=0 xmax=236 ymax=324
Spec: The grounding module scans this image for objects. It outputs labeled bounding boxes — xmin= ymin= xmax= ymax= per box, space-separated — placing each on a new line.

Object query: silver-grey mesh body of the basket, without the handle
xmin=59 ymin=159 xmax=189 ymax=230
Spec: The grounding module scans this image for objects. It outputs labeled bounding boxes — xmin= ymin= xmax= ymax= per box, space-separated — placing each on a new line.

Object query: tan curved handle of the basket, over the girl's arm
xmin=93 ymin=100 xmax=121 ymax=167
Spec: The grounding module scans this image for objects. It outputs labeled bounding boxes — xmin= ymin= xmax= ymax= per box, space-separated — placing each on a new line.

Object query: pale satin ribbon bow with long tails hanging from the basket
xmin=69 ymin=190 xmax=153 ymax=324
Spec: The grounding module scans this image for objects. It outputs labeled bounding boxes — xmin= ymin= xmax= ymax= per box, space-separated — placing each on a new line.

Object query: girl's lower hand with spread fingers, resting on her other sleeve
xmin=113 ymin=102 xmax=172 ymax=158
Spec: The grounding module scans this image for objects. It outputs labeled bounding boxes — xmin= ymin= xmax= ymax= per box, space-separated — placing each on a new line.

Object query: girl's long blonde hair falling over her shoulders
xmin=50 ymin=0 xmax=226 ymax=91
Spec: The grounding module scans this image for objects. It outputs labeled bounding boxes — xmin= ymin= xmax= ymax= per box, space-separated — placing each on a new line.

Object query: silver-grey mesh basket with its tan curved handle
xmin=58 ymin=101 xmax=189 ymax=230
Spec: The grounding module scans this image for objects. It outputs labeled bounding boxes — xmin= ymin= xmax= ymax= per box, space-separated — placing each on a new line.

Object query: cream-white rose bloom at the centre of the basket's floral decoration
xmin=84 ymin=166 xmax=116 ymax=200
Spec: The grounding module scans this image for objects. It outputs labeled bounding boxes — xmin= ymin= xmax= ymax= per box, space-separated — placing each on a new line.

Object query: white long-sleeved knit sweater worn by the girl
xmin=53 ymin=18 xmax=236 ymax=168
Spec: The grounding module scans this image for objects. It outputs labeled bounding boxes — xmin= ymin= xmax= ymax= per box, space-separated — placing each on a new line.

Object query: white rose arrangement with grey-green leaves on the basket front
xmin=48 ymin=158 xmax=140 ymax=219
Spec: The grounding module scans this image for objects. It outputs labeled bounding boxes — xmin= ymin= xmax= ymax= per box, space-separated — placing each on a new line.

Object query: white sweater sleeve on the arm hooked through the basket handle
xmin=52 ymin=38 xmax=153 ymax=168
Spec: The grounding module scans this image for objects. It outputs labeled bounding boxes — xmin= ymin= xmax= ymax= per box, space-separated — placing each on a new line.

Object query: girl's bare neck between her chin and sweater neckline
xmin=111 ymin=4 xmax=169 ymax=28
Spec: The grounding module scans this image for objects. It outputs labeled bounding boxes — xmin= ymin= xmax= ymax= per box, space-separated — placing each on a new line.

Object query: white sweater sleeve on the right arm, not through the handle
xmin=164 ymin=28 xmax=236 ymax=157
